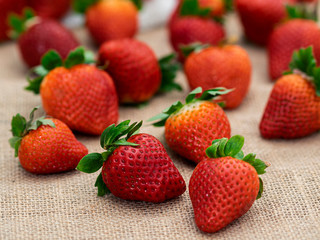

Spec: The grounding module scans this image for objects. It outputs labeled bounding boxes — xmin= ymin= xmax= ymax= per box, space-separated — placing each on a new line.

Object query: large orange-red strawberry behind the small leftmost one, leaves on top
xmin=27 ymin=48 xmax=118 ymax=135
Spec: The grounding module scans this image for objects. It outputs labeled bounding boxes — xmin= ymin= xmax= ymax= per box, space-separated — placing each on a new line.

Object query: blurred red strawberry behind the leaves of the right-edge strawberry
xmin=268 ymin=6 xmax=320 ymax=79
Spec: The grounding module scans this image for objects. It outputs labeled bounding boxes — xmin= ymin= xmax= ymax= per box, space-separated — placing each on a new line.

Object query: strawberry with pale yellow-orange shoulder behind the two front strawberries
xmin=149 ymin=87 xmax=230 ymax=163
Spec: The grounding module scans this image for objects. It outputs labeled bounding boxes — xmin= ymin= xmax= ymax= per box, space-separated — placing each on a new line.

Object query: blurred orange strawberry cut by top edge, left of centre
xmin=74 ymin=0 xmax=141 ymax=45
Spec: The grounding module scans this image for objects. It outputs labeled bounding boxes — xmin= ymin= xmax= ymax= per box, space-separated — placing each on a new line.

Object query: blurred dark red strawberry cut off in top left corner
xmin=0 ymin=0 xmax=26 ymax=42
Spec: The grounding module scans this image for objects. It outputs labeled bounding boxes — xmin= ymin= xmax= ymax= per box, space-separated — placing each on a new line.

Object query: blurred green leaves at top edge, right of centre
xmin=180 ymin=0 xmax=211 ymax=17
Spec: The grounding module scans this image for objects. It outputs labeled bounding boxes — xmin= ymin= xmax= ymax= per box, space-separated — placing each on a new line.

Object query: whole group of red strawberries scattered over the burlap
xmin=0 ymin=0 xmax=320 ymax=233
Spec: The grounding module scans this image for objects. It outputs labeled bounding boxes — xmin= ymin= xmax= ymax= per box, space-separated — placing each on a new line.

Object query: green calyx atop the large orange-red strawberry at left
xmin=25 ymin=47 xmax=95 ymax=94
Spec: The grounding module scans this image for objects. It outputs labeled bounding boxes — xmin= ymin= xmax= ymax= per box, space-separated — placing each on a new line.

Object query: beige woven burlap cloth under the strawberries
xmin=0 ymin=15 xmax=320 ymax=240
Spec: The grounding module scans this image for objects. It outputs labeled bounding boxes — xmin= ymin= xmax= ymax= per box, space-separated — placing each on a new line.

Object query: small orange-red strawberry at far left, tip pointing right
xmin=9 ymin=108 xmax=88 ymax=174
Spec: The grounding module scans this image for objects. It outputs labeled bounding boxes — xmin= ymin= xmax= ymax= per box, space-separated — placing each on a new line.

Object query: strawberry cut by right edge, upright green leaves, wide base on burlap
xmin=260 ymin=47 xmax=320 ymax=138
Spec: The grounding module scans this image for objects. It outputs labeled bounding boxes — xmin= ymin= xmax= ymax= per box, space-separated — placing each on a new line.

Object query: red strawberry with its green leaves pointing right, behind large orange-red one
xmin=98 ymin=39 xmax=181 ymax=103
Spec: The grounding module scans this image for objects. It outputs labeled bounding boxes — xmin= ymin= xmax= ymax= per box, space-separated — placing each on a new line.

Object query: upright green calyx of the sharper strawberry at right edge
xmin=284 ymin=46 xmax=320 ymax=97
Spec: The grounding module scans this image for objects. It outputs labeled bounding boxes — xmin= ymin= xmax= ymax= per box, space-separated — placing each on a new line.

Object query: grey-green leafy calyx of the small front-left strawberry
xmin=9 ymin=107 xmax=56 ymax=157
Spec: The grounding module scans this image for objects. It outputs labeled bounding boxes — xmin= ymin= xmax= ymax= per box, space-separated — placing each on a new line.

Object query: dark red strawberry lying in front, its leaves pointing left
xmin=77 ymin=120 xmax=186 ymax=202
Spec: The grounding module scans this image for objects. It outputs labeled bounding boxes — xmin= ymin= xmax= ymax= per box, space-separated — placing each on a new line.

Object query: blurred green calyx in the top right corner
xmin=286 ymin=4 xmax=318 ymax=21
